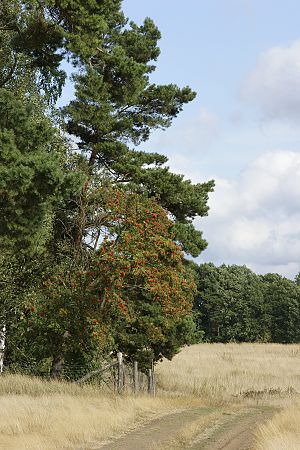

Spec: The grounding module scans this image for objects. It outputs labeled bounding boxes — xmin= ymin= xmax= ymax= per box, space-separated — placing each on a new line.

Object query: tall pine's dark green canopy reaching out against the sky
xmin=0 ymin=0 xmax=214 ymax=256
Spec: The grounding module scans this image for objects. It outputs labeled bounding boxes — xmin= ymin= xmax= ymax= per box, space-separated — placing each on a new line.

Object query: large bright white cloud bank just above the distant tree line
xmin=198 ymin=150 xmax=300 ymax=277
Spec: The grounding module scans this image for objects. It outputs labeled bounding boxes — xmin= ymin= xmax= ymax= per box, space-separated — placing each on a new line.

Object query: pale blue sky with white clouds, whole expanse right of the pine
xmin=119 ymin=0 xmax=300 ymax=278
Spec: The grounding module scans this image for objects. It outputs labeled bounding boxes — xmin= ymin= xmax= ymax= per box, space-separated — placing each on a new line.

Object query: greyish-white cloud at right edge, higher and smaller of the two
xmin=242 ymin=40 xmax=300 ymax=121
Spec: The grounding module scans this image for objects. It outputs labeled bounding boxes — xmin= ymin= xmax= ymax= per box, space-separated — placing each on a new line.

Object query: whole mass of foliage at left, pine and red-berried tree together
xmin=0 ymin=0 xmax=213 ymax=376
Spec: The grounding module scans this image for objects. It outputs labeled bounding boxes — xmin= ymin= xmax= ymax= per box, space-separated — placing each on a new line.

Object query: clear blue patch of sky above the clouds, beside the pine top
xmin=123 ymin=0 xmax=300 ymax=114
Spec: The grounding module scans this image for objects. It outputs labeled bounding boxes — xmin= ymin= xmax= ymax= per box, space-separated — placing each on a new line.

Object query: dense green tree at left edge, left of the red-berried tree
xmin=0 ymin=89 xmax=83 ymax=370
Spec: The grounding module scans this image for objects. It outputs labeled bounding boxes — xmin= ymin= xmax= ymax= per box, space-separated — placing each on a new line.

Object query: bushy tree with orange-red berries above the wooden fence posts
xmin=15 ymin=187 xmax=195 ymax=375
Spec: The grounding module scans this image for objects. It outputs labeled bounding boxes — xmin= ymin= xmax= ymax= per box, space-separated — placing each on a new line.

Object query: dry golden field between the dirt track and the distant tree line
xmin=157 ymin=344 xmax=300 ymax=404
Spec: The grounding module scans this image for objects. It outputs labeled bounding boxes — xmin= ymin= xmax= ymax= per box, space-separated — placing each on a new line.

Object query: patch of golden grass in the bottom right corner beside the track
xmin=256 ymin=401 xmax=300 ymax=450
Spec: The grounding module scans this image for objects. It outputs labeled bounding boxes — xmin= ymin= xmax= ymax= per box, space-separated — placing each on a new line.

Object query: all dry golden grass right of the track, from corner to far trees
xmin=157 ymin=344 xmax=300 ymax=450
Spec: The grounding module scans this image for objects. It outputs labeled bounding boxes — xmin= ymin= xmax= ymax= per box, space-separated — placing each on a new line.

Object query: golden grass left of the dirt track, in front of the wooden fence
xmin=0 ymin=375 xmax=199 ymax=450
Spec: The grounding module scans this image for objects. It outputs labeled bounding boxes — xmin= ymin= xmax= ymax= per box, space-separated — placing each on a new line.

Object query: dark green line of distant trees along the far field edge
xmin=194 ymin=263 xmax=300 ymax=343
